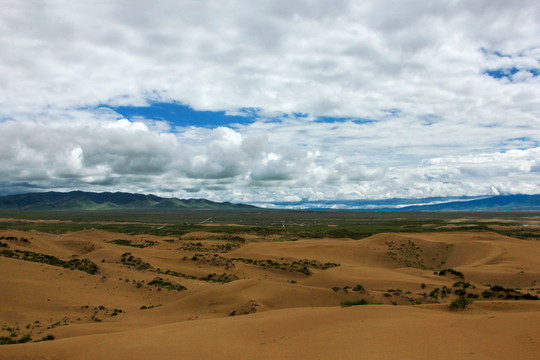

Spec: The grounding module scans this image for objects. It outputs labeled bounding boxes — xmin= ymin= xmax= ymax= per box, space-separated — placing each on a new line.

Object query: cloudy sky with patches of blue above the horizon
xmin=0 ymin=0 xmax=540 ymax=204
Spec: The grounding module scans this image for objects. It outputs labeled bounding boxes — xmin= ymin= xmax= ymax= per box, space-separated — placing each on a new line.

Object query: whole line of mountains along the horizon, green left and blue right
xmin=0 ymin=191 xmax=540 ymax=212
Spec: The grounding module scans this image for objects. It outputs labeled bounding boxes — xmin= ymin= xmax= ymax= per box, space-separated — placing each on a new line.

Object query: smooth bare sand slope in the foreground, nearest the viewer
xmin=0 ymin=306 xmax=540 ymax=359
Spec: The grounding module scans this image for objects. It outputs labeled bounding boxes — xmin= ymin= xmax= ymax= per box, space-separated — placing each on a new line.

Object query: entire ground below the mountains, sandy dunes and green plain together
xmin=0 ymin=211 xmax=540 ymax=359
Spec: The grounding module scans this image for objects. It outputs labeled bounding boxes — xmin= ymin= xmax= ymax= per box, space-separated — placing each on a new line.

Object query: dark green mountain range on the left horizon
xmin=0 ymin=191 xmax=257 ymax=211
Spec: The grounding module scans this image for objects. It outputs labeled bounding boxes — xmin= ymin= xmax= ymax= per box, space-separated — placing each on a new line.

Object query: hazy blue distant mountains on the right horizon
xmin=256 ymin=195 xmax=540 ymax=211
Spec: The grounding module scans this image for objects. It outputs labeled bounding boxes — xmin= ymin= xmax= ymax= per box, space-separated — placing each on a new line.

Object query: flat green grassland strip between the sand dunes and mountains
xmin=0 ymin=210 xmax=540 ymax=240
